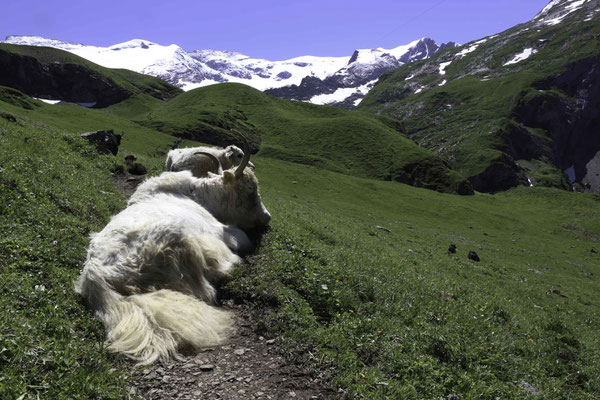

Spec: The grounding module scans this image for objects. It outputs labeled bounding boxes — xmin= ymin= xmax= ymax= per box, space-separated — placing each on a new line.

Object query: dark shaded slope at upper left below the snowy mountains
xmin=0 ymin=43 xmax=181 ymax=108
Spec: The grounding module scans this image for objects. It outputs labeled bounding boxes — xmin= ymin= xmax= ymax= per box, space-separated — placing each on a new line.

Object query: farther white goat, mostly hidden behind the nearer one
xmin=165 ymin=145 xmax=254 ymax=178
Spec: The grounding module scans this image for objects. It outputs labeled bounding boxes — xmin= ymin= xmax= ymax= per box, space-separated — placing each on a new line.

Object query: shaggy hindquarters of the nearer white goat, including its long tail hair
xmin=76 ymin=222 xmax=239 ymax=364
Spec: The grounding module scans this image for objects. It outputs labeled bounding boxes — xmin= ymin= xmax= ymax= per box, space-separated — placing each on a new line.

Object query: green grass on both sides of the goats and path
xmin=0 ymin=89 xmax=600 ymax=399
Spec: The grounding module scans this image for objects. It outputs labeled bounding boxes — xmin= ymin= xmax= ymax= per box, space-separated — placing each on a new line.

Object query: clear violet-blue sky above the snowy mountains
xmin=0 ymin=0 xmax=549 ymax=60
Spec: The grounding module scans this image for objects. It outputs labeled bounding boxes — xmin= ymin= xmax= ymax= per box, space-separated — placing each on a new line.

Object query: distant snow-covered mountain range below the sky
xmin=4 ymin=36 xmax=456 ymax=107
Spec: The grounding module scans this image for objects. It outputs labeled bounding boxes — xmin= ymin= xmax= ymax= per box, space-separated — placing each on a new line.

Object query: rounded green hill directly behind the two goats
xmin=138 ymin=83 xmax=472 ymax=194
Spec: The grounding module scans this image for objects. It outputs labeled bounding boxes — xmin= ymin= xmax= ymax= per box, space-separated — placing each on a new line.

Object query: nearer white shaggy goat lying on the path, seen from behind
xmin=76 ymin=148 xmax=271 ymax=364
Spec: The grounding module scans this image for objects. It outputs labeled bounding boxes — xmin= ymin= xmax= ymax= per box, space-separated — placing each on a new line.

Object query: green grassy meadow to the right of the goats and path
xmin=244 ymin=159 xmax=600 ymax=399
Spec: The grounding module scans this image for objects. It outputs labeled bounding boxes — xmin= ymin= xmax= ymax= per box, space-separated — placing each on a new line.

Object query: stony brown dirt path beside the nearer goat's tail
xmin=130 ymin=300 xmax=340 ymax=400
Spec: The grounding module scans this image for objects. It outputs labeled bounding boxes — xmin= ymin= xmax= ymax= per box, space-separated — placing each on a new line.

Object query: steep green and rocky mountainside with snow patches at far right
xmin=359 ymin=0 xmax=600 ymax=192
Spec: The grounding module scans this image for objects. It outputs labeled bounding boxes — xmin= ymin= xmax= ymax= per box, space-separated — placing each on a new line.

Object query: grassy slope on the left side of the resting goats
xmin=0 ymin=115 xmax=132 ymax=399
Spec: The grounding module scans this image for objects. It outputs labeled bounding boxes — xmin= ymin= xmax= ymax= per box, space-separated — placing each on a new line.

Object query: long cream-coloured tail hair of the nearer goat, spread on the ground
xmin=76 ymin=260 xmax=233 ymax=364
